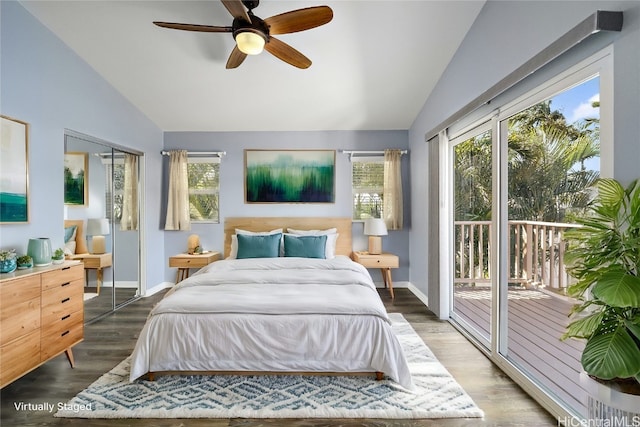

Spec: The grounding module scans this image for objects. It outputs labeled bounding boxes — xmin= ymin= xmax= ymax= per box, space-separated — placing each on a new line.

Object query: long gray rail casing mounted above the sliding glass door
xmin=425 ymin=10 xmax=622 ymax=141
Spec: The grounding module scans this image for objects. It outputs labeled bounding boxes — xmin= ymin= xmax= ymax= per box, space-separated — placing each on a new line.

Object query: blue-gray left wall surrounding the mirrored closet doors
xmin=0 ymin=1 xmax=167 ymax=286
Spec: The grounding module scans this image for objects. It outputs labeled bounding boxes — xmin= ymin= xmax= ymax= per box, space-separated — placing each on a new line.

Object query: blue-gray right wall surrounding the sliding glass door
xmin=409 ymin=1 xmax=640 ymax=313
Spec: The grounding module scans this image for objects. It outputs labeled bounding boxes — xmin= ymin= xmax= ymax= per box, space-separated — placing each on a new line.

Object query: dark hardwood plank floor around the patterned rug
xmin=0 ymin=289 xmax=558 ymax=427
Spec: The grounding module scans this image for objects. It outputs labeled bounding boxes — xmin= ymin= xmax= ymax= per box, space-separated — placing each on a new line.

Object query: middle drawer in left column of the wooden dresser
xmin=0 ymin=293 xmax=40 ymax=346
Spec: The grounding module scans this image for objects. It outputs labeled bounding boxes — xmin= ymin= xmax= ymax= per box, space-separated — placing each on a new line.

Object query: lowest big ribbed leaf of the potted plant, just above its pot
xmin=582 ymin=323 xmax=640 ymax=380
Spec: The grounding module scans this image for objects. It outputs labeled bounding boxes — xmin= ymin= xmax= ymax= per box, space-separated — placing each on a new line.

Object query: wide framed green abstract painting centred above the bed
xmin=244 ymin=150 xmax=336 ymax=203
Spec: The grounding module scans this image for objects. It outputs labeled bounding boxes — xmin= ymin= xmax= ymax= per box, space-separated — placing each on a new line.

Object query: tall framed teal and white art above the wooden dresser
xmin=0 ymin=116 xmax=29 ymax=224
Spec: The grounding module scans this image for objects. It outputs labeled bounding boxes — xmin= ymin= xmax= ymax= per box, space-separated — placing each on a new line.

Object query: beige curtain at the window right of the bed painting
xmin=383 ymin=150 xmax=403 ymax=230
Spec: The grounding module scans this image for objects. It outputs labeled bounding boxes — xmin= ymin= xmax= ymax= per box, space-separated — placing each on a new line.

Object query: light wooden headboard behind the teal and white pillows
xmin=224 ymin=217 xmax=353 ymax=258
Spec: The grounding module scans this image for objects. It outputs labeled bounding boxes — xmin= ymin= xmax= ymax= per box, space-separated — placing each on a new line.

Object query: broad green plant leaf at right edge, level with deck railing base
xmin=592 ymin=270 xmax=640 ymax=308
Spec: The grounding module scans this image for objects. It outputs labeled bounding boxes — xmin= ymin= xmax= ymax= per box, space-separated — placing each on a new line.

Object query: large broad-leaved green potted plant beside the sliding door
xmin=563 ymin=179 xmax=640 ymax=420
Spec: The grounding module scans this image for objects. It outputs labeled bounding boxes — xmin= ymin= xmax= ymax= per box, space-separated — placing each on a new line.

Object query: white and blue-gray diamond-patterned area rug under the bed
xmin=55 ymin=313 xmax=484 ymax=418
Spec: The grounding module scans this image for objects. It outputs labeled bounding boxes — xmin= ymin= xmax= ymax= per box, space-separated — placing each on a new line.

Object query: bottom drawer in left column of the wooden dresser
xmin=0 ymin=330 xmax=40 ymax=387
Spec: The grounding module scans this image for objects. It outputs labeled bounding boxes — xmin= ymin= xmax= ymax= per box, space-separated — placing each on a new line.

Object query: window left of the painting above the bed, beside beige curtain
xmin=187 ymin=156 xmax=220 ymax=223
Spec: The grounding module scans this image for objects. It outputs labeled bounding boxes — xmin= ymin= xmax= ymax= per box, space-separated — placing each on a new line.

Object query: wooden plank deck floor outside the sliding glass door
xmin=454 ymin=287 xmax=586 ymax=414
